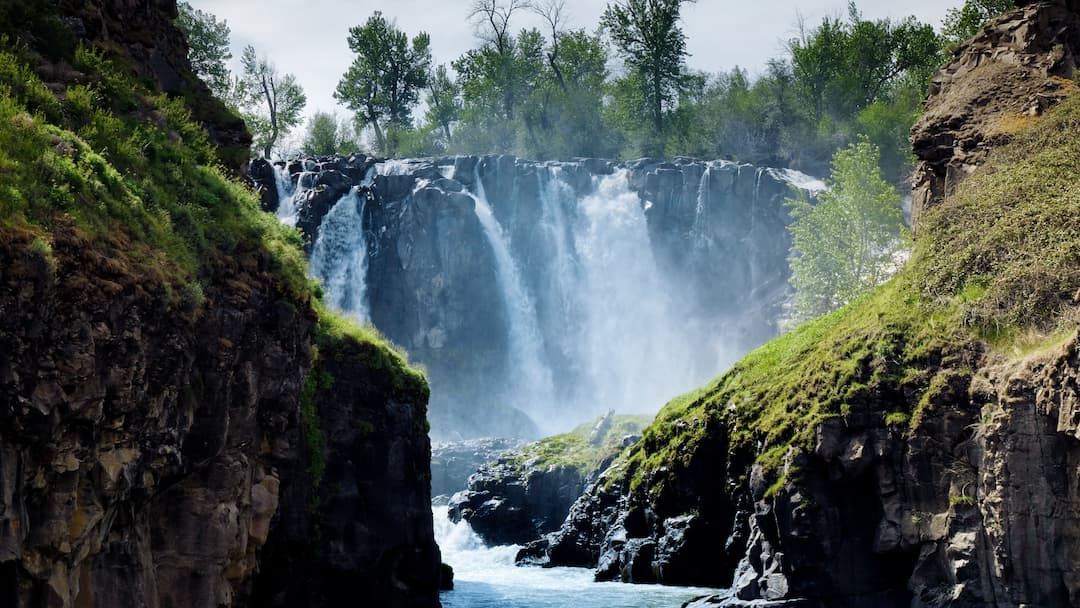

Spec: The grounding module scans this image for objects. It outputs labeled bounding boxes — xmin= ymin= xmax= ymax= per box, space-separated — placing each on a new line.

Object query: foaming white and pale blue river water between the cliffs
xmin=432 ymin=506 xmax=717 ymax=608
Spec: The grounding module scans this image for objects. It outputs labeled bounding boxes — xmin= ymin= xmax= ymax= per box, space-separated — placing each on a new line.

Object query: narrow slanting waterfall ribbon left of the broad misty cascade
xmin=473 ymin=166 xmax=554 ymax=427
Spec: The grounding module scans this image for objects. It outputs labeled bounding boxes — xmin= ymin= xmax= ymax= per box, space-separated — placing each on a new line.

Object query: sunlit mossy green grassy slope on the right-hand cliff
xmin=624 ymin=96 xmax=1080 ymax=498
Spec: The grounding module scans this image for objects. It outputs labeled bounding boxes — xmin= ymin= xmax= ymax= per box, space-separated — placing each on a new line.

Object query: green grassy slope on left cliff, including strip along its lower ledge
xmin=0 ymin=23 xmax=428 ymax=414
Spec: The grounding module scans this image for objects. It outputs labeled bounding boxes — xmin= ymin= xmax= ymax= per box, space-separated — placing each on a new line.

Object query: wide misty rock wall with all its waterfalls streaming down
xmin=252 ymin=154 xmax=822 ymax=438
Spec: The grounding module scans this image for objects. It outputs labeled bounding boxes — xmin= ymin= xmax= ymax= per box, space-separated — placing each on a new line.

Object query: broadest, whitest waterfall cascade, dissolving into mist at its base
xmin=575 ymin=170 xmax=701 ymax=411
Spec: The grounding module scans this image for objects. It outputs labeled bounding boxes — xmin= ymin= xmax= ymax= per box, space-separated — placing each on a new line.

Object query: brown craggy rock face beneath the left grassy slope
xmin=0 ymin=230 xmax=312 ymax=607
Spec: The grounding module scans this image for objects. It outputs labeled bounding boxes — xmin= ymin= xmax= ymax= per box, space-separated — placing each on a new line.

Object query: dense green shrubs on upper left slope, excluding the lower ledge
xmin=0 ymin=42 xmax=310 ymax=305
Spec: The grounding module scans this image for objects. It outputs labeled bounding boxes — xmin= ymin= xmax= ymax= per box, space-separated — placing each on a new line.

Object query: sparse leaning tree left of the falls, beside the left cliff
xmin=240 ymin=45 xmax=308 ymax=159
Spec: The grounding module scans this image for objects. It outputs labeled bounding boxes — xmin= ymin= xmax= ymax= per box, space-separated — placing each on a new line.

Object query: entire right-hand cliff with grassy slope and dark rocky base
xmin=534 ymin=2 xmax=1080 ymax=607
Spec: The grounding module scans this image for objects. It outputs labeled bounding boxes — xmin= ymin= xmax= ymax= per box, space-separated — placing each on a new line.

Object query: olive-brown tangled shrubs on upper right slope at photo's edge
xmin=915 ymin=96 xmax=1080 ymax=334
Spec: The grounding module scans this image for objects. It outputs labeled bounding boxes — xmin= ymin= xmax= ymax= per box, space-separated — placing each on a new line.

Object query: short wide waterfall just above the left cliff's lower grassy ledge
xmin=310 ymin=188 xmax=370 ymax=322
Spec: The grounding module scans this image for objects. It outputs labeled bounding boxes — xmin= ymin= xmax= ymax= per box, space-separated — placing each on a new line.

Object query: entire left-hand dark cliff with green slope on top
xmin=0 ymin=0 xmax=440 ymax=608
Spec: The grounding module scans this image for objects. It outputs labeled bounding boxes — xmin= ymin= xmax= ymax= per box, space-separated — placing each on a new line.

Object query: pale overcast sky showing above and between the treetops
xmin=189 ymin=0 xmax=962 ymax=127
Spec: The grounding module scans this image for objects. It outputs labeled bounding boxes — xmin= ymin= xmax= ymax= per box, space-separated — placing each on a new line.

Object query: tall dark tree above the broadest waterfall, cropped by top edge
xmin=600 ymin=0 xmax=693 ymax=152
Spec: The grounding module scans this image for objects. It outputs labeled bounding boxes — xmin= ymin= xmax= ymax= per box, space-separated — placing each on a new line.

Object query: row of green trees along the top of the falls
xmin=180 ymin=0 xmax=1012 ymax=183
